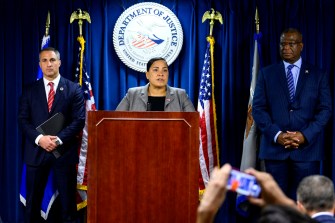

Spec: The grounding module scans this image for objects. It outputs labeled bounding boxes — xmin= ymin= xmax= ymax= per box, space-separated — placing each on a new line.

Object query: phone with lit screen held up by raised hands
xmin=227 ymin=169 xmax=261 ymax=197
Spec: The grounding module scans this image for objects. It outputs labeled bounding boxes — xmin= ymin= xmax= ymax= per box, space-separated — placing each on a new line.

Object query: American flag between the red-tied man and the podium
xmin=75 ymin=36 xmax=96 ymax=210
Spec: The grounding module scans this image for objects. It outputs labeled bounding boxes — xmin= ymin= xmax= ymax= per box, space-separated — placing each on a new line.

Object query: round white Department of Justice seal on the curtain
xmin=113 ymin=2 xmax=183 ymax=72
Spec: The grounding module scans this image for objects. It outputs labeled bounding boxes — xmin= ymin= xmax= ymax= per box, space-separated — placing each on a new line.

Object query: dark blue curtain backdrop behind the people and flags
xmin=0 ymin=0 xmax=335 ymax=223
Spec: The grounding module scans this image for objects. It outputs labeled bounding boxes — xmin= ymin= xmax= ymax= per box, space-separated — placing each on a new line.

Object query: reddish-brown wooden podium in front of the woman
xmin=87 ymin=111 xmax=199 ymax=223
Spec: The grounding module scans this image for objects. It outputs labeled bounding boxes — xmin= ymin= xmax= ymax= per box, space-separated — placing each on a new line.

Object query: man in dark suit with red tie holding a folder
xmin=19 ymin=47 xmax=85 ymax=223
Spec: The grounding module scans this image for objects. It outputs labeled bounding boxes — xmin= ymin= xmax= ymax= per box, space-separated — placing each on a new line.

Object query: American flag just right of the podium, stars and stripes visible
xmin=198 ymin=37 xmax=219 ymax=195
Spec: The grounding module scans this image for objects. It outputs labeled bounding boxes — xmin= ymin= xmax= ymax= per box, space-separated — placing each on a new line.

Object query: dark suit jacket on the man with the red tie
xmin=19 ymin=77 xmax=85 ymax=166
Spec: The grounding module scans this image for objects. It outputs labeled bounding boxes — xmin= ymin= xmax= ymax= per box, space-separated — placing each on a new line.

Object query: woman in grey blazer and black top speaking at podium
xmin=116 ymin=57 xmax=195 ymax=112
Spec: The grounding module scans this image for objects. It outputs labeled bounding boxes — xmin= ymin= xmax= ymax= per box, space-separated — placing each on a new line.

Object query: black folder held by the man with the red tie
xmin=36 ymin=112 xmax=65 ymax=158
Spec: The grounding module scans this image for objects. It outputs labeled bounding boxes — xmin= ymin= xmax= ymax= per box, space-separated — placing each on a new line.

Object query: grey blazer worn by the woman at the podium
xmin=116 ymin=84 xmax=195 ymax=112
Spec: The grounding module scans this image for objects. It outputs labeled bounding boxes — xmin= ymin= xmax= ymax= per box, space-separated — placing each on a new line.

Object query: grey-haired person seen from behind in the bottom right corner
xmin=297 ymin=175 xmax=335 ymax=223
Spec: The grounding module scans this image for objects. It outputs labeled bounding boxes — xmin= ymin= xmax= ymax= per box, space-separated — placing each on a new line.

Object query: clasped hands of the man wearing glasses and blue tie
xmin=277 ymin=131 xmax=305 ymax=149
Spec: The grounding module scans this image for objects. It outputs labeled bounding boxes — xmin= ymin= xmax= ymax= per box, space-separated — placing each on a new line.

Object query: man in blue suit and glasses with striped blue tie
xmin=252 ymin=28 xmax=332 ymax=200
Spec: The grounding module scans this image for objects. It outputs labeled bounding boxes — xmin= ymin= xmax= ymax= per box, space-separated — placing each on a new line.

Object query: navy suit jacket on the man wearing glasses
xmin=252 ymin=61 xmax=332 ymax=161
